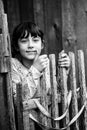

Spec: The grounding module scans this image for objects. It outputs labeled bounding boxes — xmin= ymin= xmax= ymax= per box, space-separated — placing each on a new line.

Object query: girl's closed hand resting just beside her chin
xmin=33 ymin=54 xmax=49 ymax=72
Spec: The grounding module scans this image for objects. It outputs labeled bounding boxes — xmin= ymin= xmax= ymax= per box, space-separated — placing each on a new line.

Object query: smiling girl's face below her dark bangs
xmin=18 ymin=34 xmax=43 ymax=60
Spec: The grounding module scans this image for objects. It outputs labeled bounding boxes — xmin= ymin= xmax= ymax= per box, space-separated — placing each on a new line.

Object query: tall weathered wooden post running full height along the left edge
xmin=0 ymin=0 xmax=16 ymax=130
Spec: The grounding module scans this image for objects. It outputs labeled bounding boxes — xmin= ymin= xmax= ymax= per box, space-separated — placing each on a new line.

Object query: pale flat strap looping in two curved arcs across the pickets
xmin=29 ymin=91 xmax=87 ymax=130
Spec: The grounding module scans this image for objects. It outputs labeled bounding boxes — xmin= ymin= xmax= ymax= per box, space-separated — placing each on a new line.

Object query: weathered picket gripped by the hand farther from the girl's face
xmin=58 ymin=68 xmax=70 ymax=130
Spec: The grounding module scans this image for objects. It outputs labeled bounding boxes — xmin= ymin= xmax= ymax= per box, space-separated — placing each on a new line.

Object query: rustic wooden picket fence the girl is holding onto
xmin=17 ymin=50 xmax=87 ymax=130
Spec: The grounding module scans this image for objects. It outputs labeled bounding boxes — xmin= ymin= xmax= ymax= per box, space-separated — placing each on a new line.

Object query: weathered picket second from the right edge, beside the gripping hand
xmin=69 ymin=52 xmax=79 ymax=130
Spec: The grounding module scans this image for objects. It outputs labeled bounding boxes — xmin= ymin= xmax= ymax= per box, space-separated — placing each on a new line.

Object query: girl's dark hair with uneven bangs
xmin=11 ymin=22 xmax=44 ymax=57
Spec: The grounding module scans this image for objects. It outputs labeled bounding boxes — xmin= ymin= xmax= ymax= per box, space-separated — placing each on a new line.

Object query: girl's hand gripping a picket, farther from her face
xmin=58 ymin=50 xmax=70 ymax=69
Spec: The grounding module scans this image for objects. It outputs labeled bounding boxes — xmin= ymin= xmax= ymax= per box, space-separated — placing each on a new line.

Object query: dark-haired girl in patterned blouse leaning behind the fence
xmin=12 ymin=22 xmax=70 ymax=100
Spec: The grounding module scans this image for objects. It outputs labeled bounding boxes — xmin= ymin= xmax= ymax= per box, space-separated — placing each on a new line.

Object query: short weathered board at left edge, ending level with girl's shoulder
xmin=0 ymin=14 xmax=10 ymax=72
